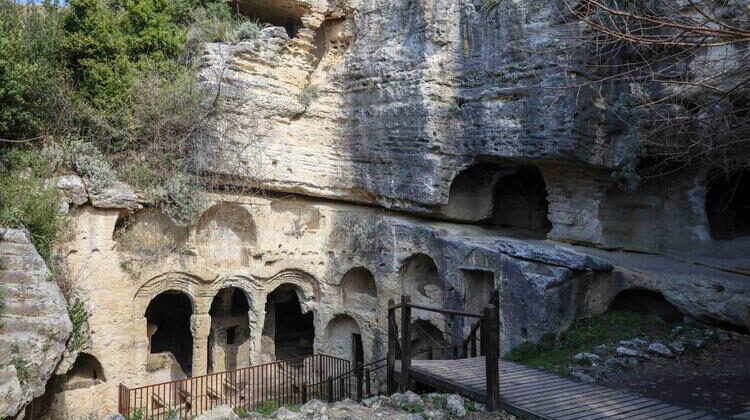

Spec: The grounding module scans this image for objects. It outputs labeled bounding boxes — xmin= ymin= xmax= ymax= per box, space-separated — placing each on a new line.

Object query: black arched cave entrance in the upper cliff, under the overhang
xmin=491 ymin=166 xmax=552 ymax=235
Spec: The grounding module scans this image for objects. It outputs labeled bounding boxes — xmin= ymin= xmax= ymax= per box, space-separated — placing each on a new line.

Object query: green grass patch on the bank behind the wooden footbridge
xmin=507 ymin=312 xmax=675 ymax=374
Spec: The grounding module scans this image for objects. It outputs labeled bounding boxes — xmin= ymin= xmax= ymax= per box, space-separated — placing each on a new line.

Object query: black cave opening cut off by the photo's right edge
xmin=706 ymin=171 xmax=750 ymax=240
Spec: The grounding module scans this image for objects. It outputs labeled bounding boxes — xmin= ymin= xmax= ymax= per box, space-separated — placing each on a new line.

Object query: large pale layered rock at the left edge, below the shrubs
xmin=0 ymin=229 xmax=72 ymax=418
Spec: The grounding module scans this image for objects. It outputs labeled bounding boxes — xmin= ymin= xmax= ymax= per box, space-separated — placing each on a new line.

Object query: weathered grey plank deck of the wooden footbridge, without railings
xmin=396 ymin=357 xmax=720 ymax=420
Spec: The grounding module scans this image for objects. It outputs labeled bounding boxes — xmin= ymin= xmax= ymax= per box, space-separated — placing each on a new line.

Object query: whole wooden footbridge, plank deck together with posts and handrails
xmin=387 ymin=296 xmax=719 ymax=420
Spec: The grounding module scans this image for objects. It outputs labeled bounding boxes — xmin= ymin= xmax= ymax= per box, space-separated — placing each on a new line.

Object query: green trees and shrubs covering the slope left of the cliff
xmin=0 ymin=0 xmax=259 ymax=249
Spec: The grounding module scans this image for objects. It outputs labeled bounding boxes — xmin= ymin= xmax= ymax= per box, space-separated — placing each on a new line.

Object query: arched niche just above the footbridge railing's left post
xmin=401 ymin=253 xmax=444 ymax=315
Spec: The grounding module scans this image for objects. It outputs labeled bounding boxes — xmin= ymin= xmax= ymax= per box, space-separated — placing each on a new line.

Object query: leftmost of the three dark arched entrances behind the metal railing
xmin=146 ymin=291 xmax=193 ymax=376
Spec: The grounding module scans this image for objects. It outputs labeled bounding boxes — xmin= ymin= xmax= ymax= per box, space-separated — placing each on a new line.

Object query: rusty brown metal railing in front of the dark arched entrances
xmin=118 ymin=354 xmax=354 ymax=420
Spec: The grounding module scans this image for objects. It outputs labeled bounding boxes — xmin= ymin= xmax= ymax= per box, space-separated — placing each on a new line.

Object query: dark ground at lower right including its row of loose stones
xmin=568 ymin=325 xmax=750 ymax=416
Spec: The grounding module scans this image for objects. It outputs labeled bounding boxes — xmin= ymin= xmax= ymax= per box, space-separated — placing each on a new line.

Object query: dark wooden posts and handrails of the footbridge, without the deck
xmin=387 ymin=291 xmax=500 ymax=411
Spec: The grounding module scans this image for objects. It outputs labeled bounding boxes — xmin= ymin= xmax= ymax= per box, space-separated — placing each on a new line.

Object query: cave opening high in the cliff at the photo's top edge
xmin=231 ymin=0 xmax=308 ymax=38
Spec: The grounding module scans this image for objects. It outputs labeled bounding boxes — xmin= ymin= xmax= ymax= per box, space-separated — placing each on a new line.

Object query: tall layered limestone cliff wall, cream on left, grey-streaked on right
xmin=198 ymin=0 xmax=616 ymax=212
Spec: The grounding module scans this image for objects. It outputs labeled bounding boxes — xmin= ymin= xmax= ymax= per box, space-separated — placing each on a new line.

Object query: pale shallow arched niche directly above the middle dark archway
xmin=196 ymin=203 xmax=256 ymax=267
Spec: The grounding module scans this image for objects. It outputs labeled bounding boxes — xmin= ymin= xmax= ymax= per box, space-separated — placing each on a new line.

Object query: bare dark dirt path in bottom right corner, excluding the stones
xmin=602 ymin=336 xmax=750 ymax=416
